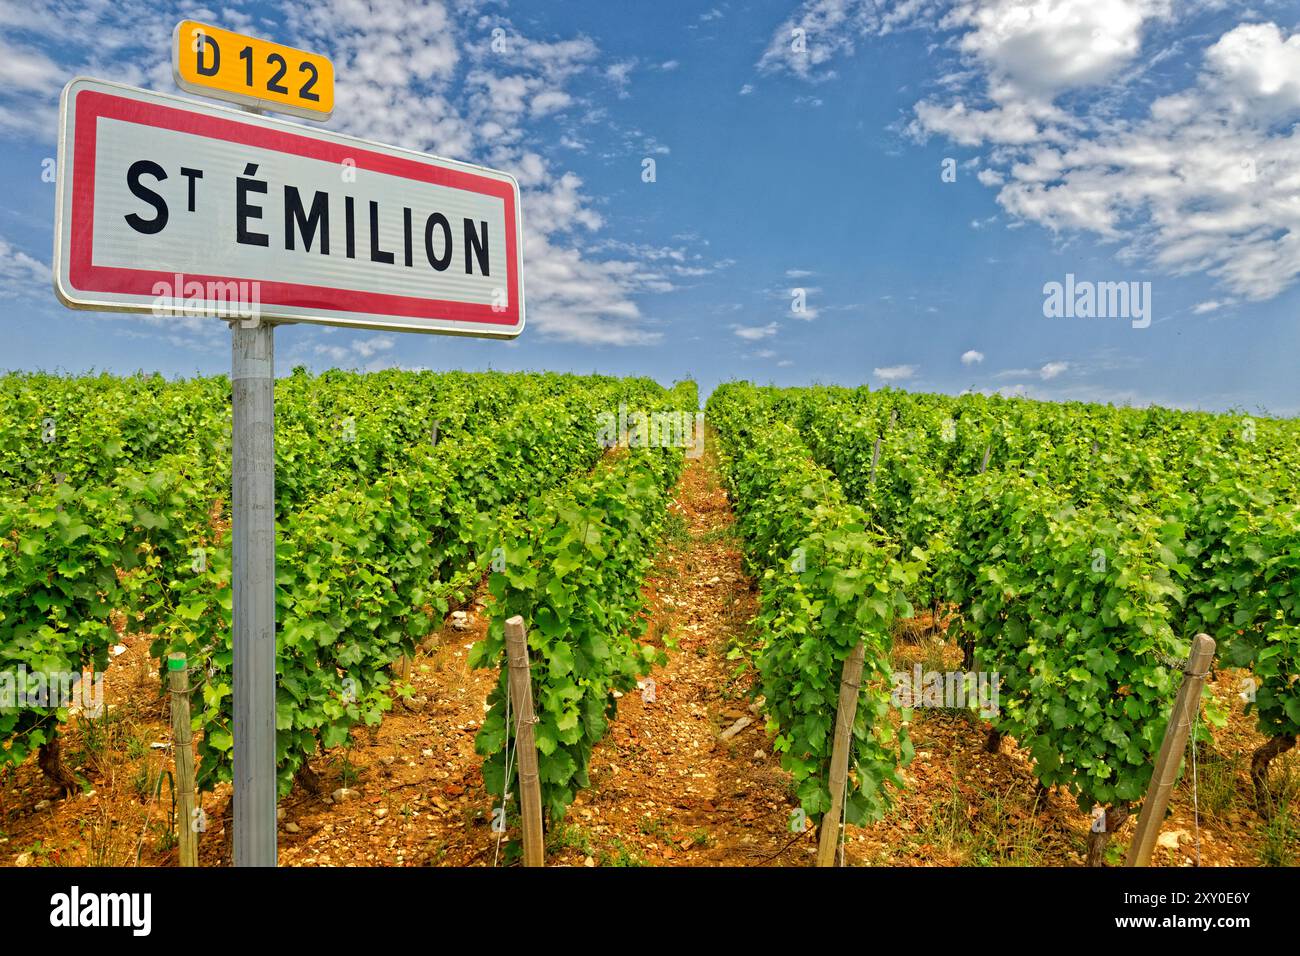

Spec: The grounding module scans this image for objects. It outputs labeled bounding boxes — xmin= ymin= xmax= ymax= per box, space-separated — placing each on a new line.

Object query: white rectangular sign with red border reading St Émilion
xmin=55 ymin=78 xmax=524 ymax=338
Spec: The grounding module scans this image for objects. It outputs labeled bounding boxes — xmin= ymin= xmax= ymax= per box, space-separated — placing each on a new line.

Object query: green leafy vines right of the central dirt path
xmin=710 ymin=385 xmax=1300 ymax=862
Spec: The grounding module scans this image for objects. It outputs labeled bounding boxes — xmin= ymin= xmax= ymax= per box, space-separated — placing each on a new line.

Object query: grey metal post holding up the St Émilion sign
xmin=230 ymin=321 xmax=276 ymax=866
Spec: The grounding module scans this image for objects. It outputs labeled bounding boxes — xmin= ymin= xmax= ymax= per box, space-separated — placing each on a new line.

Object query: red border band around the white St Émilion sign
xmin=68 ymin=90 xmax=520 ymax=325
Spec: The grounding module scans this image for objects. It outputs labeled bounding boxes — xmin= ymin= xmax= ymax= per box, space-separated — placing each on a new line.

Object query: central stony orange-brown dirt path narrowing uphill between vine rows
xmin=551 ymin=442 xmax=814 ymax=866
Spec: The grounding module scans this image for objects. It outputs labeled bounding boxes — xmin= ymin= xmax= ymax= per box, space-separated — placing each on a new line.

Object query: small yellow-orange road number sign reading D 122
xmin=172 ymin=20 xmax=334 ymax=120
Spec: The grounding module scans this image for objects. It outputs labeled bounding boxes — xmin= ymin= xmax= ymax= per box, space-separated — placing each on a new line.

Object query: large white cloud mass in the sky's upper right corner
xmin=907 ymin=8 xmax=1300 ymax=299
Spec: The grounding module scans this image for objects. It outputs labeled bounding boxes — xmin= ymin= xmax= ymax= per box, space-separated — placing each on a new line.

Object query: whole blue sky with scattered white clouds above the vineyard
xmin=0 ymin=0 xmax=1300 ymax=415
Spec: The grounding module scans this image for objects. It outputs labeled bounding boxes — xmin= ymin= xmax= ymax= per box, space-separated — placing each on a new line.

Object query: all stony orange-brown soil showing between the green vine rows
xmin=0 ymin=442 xmax=1300 ymax=866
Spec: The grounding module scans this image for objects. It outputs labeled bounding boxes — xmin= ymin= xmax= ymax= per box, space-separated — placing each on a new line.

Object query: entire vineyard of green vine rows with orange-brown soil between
xmin=0 ymin=368 xmax=1300 ymax=865
